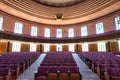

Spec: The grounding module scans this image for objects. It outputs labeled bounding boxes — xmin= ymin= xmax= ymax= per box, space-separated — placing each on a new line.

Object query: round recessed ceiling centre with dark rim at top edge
xmin=33 ymin=0 xmax=84 ymax=7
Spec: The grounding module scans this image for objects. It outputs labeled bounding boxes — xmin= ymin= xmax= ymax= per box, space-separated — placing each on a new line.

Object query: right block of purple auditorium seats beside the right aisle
xmin=78 ymin=52 xmax=120 ymax=80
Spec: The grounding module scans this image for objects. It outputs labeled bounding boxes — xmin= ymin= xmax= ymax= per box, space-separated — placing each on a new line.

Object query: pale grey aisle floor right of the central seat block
xmin=73 ymin=54 xmax=100 ymax=80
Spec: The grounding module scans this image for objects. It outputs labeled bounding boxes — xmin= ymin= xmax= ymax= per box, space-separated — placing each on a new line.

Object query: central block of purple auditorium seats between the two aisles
xmin=35 ymin=52 xmax=81 ymax=80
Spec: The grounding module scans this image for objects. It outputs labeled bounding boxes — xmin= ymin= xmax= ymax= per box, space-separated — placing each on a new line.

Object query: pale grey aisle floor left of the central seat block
xmin=17 ymin=54 xmax=46 ymax=80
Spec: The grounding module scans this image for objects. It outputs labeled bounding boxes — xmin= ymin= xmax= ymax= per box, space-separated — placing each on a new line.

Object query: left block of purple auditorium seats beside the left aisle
xmin=0 ymin=52 xmax=40 ymax=80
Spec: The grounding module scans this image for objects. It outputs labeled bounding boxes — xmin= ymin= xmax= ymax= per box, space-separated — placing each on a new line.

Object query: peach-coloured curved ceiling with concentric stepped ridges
xmin=0 ymin=0 xmax=120 ymax=25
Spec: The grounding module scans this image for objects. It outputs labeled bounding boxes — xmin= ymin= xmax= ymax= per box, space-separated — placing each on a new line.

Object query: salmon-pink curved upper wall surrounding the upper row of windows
xmin=0 ymin=10 xmax=120 ymax=37
